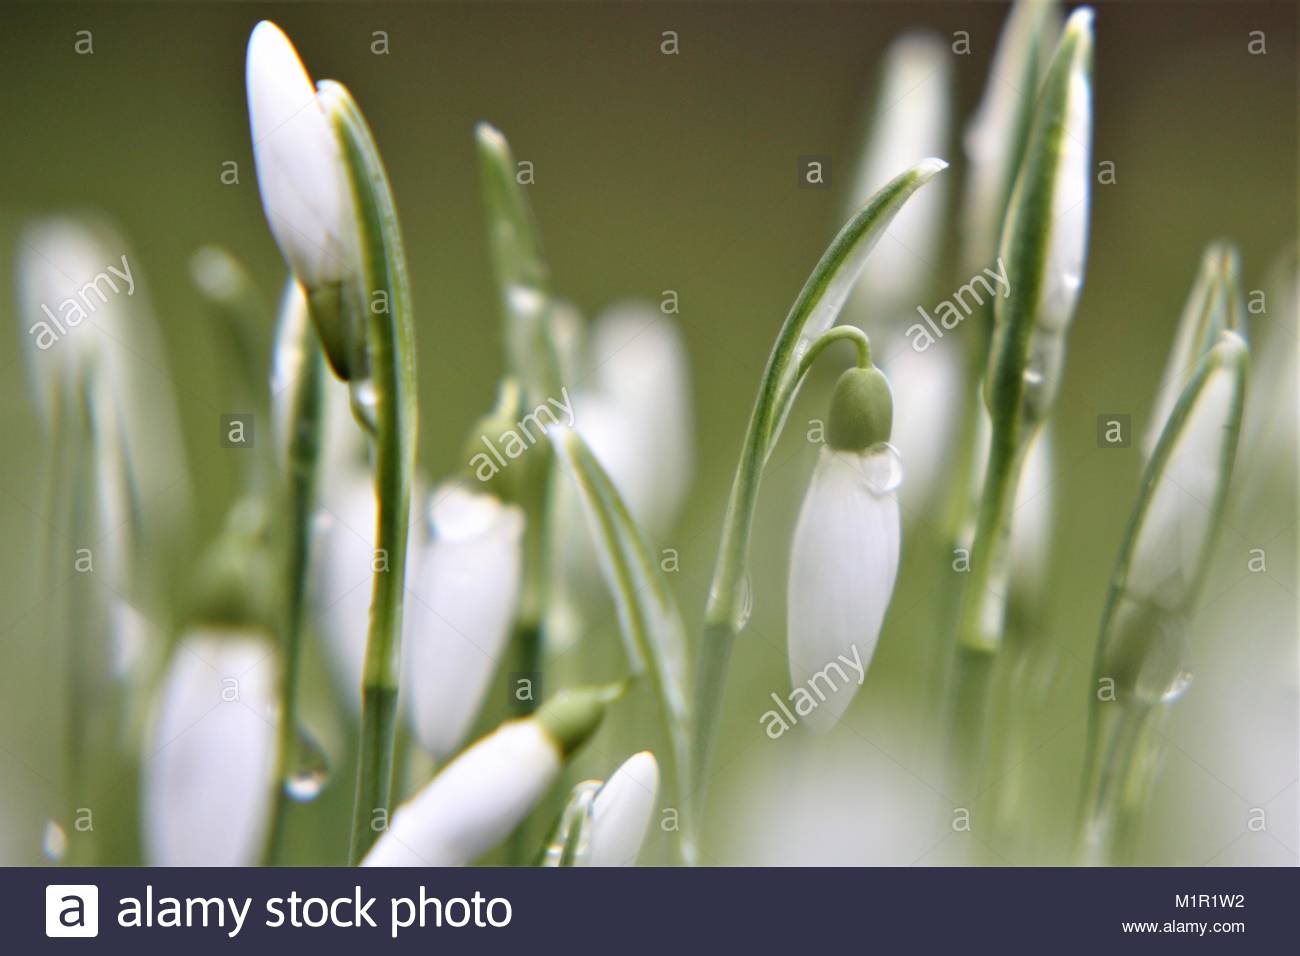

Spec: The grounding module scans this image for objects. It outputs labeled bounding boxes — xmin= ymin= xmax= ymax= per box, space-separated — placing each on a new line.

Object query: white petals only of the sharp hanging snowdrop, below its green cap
xmin=788 ymin=447 xmax=900 ymax=730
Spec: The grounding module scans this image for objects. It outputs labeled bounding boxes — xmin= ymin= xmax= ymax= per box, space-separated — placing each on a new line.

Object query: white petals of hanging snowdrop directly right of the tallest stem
xmin=402 ymin=483 xmax=524 ymax=761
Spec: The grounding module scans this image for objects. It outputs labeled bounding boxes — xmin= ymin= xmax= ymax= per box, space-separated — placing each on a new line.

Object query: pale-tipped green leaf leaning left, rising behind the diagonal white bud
xmin=547 ymin=425 xmax=692 ymax=853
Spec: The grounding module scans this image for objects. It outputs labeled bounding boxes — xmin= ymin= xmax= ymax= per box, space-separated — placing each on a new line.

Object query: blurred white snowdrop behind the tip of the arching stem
xmin=850 ymin=34 xmax=952 ymax=313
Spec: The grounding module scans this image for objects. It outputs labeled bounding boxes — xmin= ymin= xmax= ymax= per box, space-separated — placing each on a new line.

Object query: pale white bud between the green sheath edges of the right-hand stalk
xmin=1127 ymin=351 xmax=1244 ymax=609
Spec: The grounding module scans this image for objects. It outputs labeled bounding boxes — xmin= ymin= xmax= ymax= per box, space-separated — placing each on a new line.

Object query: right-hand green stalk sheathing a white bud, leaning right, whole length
xmin=1078 ymin=332 xmax=1248 ymax=862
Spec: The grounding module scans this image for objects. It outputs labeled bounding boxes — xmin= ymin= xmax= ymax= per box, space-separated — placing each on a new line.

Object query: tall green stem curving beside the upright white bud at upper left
xmin=320 ymin=82 xmax=416 ymax=864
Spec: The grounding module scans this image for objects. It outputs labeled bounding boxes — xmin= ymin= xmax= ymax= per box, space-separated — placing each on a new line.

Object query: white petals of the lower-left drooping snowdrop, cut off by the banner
xmin=142 ymin=628 xmax=276 ymax=866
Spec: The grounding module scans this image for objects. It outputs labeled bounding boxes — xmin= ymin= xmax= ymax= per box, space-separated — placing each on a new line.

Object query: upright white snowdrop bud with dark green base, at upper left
xmin=246 ymin=21 xmax=364 ymax=380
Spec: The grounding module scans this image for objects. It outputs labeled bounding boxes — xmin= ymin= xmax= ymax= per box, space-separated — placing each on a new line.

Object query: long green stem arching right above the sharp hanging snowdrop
xmin=692 ymin=160 xmax=945 ymax=800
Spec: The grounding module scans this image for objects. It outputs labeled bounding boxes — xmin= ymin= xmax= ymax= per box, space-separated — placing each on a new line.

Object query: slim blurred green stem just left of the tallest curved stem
xmin=267 ymin=287 xmax=325 ymax=864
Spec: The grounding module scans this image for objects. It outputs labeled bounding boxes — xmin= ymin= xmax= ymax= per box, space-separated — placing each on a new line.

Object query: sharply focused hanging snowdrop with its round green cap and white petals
xmin=787 ymin=368 xmax=901 ymax=730
